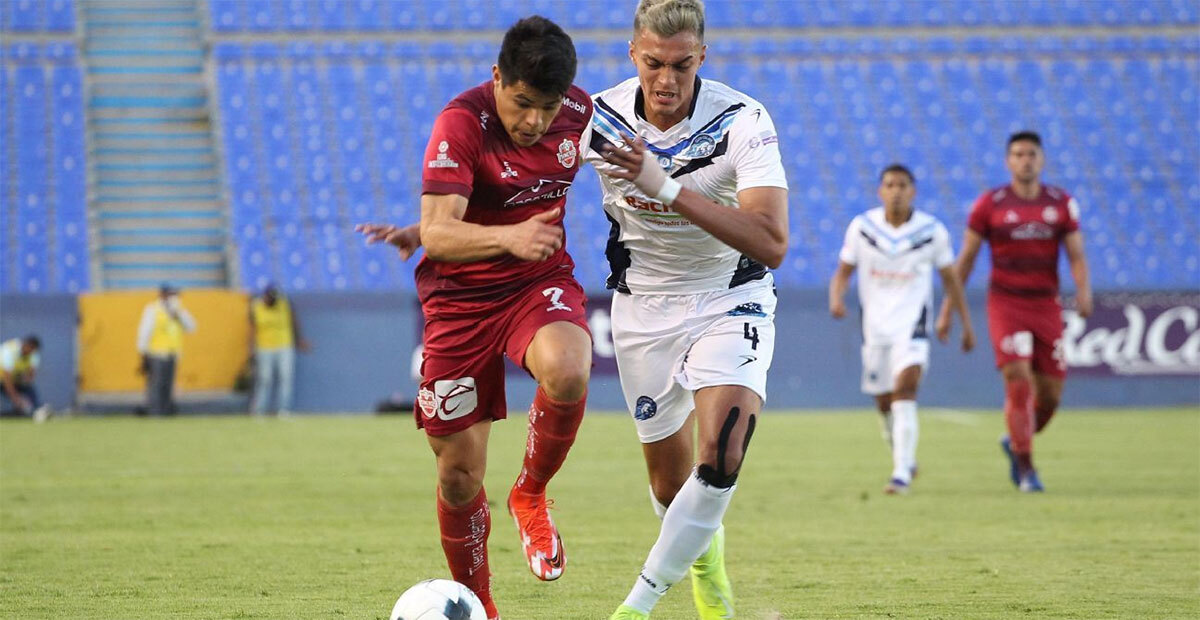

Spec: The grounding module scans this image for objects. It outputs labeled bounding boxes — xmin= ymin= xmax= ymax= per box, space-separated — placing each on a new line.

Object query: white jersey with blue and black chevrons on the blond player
xmin=587 ymin=78 xmax=787 ymax=294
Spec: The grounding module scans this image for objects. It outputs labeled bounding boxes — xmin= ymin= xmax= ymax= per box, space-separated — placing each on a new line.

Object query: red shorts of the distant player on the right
xmin=988 ymin=291 xmax=1067 ymax=378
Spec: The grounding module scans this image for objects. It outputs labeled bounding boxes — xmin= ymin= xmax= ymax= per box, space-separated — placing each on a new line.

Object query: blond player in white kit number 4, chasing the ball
xmin=588 ymin=0 xmax=788 ymax=619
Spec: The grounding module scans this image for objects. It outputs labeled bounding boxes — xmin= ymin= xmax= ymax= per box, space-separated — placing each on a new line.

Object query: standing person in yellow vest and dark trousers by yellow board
xmin=138 ymin=283 xmax=196 ymax=415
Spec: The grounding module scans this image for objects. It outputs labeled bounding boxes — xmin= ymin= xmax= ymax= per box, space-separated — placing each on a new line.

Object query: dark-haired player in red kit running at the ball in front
xmin=359 ymin=17 xmax=592 ymax=619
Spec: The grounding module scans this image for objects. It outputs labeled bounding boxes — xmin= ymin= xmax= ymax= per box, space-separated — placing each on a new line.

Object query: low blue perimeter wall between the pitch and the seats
xmin=0 ymin=290 xmax=1200 ymax=411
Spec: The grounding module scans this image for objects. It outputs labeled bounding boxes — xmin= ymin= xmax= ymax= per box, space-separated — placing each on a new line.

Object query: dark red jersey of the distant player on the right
xmin=967 ymin=185 xmax=1079 ymax=297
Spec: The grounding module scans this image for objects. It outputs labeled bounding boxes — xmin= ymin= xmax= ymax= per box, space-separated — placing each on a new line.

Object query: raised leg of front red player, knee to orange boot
xmin=508 ymin=321 xmax=592 ymax=582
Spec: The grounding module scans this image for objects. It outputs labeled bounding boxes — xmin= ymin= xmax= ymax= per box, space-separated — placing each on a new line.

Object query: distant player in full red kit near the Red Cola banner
xmin=940 ymin=131 xmax=1092 ymax=493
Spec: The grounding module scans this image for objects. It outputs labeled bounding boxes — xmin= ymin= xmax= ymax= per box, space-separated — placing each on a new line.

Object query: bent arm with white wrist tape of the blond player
xmin=602 ymin=136 xmax=787 ymax=269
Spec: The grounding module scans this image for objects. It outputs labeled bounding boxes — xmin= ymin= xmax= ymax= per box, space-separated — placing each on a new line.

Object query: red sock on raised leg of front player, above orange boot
xmin=516 ymin=387 xmax=588 ymax=495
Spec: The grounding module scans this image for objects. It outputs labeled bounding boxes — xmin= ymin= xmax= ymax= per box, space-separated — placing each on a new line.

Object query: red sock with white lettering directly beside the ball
xmin=438 ymin=488 xmax=499 ymax=618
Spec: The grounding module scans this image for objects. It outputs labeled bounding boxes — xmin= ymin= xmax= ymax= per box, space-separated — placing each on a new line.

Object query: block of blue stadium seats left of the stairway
xmin=0 ymin=0 xmax=89 ymax=293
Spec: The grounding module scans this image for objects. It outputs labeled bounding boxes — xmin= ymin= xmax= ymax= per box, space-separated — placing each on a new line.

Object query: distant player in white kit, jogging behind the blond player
xmin=829 ymin=164 xmax=974 ymax=494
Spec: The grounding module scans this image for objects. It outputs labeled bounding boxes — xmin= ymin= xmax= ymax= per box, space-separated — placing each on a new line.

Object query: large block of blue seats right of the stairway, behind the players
xmin=215 ymin=41 xmax=1200 ymax=288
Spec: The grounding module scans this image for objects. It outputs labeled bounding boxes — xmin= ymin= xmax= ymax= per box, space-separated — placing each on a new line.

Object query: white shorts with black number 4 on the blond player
xmin=612 ymin=276 xmax=775 ymax=444
